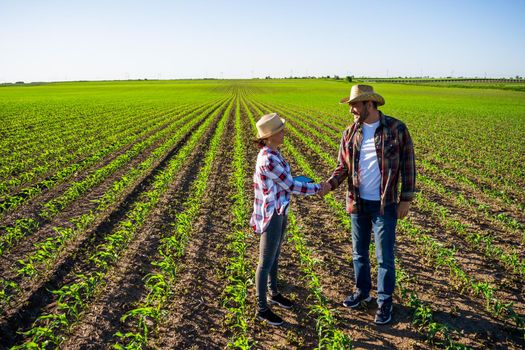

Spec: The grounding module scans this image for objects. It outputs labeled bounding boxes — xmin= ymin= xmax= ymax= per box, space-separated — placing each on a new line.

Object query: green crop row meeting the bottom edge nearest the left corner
xmin=8 ymin=96 xmax=231 ymax=349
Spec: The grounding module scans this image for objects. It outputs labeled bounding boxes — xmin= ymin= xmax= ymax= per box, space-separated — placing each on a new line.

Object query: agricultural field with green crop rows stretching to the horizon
xmin=0 ymin=79 xmax=525 ymax=349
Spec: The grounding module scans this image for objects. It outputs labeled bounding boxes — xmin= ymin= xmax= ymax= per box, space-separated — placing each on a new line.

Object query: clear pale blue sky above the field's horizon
xmin=0 ymin=0 xmax=525 ymax=82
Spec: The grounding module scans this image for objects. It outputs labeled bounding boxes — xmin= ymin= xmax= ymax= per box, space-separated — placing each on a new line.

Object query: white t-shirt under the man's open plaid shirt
xmin=359 ymin=120 xmax=381 ymax=201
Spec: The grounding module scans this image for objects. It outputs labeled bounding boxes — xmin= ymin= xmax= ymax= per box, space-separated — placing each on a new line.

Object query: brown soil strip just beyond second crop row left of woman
xmin=63 ymin=105 xmax=214 ymax=349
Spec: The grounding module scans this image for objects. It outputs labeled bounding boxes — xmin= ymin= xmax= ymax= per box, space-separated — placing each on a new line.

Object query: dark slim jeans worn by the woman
xmin=255 ymin=213 xmax=288 ymax=310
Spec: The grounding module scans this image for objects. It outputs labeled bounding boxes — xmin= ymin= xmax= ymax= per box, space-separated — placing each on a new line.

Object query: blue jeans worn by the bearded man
xmin=351 ymin=199 xmax=397 ymax=306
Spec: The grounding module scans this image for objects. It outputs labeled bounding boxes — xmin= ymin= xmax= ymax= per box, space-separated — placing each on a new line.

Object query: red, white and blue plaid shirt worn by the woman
xmin=250 ymin=146 xmax=321 ymax=233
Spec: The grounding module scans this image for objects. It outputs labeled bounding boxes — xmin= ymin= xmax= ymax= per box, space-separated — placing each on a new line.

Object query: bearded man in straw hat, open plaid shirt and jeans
xmin=320 ymin=85 xmax=416 ymax=324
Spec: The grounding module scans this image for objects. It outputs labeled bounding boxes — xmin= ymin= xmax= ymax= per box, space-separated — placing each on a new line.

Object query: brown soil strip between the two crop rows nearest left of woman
xmin=151 ymin=102 xmax=234 ymax=349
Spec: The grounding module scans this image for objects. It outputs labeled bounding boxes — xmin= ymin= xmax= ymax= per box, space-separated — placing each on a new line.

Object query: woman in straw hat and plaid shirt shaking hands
xmin=250 ymin=113 xmax=327 ymax=326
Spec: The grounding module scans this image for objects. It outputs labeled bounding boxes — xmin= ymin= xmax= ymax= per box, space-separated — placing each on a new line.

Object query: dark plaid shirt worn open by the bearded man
xmin=328 ymin=111 xmax=416 ymax=214
